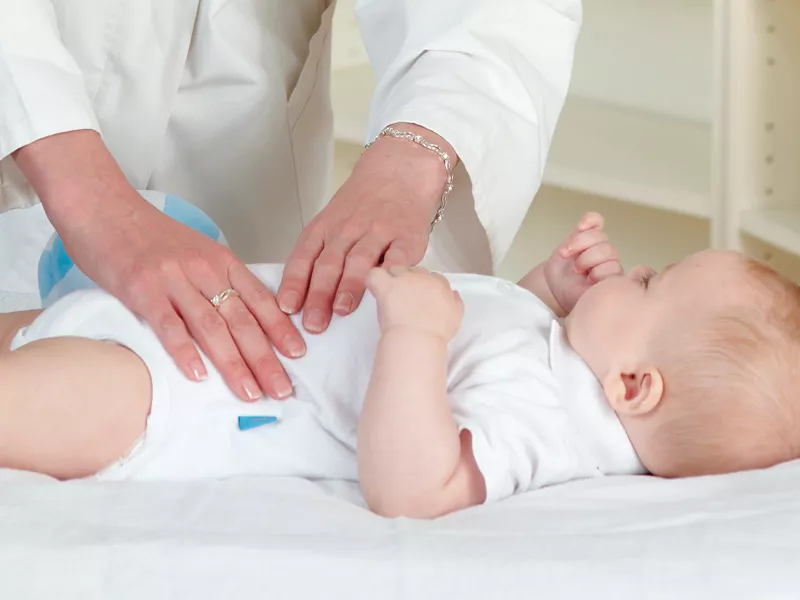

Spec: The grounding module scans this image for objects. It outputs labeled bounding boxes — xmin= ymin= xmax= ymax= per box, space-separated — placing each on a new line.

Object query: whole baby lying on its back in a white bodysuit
xmin=0 ymin=213 xmax=800 ymax=518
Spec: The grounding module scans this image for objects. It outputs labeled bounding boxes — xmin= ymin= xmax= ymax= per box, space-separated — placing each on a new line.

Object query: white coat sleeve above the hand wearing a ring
xmin=0 ymin=0 xmax=100 ymax=166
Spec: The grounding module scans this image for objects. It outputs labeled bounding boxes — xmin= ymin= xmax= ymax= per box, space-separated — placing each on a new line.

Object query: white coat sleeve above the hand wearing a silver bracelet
xmin=356 ymin=0 xmax=582 ymax=267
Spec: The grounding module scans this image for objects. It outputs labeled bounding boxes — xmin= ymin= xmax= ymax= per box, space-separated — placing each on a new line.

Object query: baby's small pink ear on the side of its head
xmin=603 ymin=365 xmax=664 ymax=416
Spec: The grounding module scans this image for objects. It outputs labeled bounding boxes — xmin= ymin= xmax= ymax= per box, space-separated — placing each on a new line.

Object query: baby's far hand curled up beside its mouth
xmin=544 ymin=213 xmax=623 ymax=314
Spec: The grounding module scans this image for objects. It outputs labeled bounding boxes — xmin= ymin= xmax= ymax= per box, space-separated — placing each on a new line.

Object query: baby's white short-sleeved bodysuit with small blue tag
xmin=12 ymin=265 xmax=644 ymax=501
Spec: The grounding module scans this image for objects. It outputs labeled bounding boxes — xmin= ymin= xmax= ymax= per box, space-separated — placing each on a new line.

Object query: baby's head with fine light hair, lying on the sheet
xmin=566 ymin=251 xmax=800 ymax=477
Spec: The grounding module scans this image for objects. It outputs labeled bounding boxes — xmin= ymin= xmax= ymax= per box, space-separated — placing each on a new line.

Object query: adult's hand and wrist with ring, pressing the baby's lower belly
xmin=15 ymin=131 xmax=305 ymax=400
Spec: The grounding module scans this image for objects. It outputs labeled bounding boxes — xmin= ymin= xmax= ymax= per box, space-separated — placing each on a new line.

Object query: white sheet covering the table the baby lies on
xmin=0 ymin=206 xmax=800 ymax=600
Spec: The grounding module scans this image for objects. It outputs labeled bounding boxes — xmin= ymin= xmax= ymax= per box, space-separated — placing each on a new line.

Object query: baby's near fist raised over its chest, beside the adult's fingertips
xmin=367 ymin=266 xmax=464 ymax=342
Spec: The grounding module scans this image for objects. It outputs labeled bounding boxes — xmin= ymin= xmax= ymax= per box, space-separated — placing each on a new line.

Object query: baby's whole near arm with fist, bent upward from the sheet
xmin=358 ymin=267 xmax=486 ymax=518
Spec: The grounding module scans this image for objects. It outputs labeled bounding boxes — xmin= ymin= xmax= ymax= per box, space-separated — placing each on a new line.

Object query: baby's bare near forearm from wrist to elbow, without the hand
xmin=358 ymin=329 xmax=461 ymax=516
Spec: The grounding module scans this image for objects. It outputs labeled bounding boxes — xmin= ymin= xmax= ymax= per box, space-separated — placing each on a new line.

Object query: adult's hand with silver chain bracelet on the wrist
xmin=277 ymin=123 xmax=456 ymax=333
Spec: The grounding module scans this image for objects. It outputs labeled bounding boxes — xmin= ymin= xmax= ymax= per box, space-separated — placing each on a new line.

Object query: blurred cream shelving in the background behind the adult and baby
xmin=332 ymin=0 xmax=800 ymax=281
